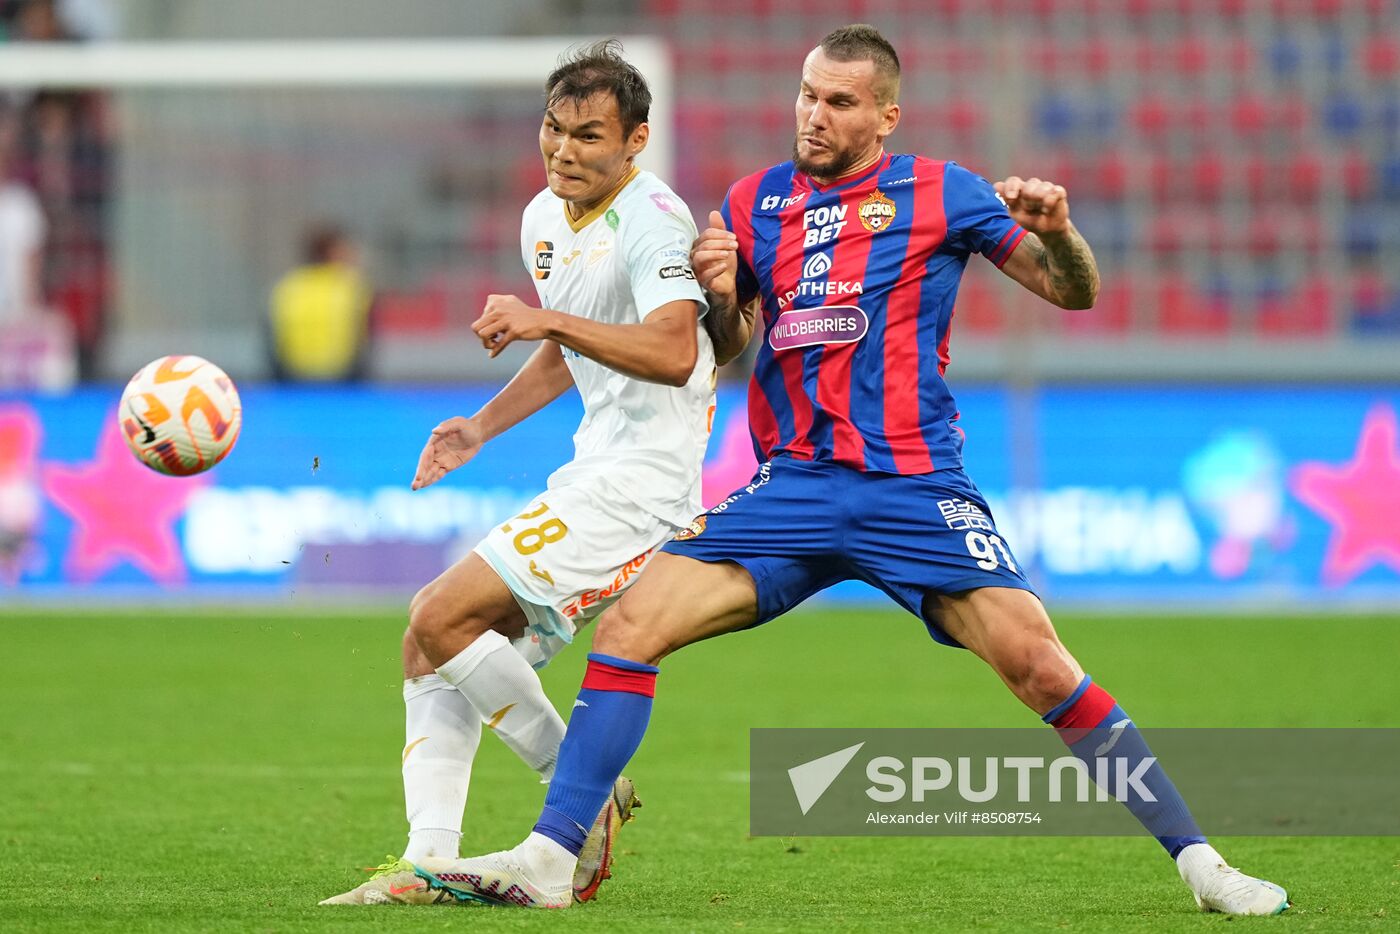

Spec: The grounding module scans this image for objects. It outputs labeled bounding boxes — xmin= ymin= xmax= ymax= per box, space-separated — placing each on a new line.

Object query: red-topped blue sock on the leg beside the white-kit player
xmin=535 ymin=653 xmax=658 ymax=856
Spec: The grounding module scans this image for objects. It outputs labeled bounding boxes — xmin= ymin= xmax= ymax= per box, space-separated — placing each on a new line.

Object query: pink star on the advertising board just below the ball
xmin=43 ymin=417 xmax=207 ymax=584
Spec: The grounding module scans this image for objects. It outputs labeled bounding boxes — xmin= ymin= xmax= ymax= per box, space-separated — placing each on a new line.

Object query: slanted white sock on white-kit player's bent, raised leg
xmin=438 ymin=630 xmax=564 ymax=781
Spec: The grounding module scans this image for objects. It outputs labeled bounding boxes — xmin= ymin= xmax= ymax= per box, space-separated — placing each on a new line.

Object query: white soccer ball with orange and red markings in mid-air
xmin=116 ymin=354 xmax=244 ymax=476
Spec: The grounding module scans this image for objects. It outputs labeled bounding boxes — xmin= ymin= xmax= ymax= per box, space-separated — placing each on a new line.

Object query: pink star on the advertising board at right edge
xmin=1289 ymin=405 xmax=1400 ymax=584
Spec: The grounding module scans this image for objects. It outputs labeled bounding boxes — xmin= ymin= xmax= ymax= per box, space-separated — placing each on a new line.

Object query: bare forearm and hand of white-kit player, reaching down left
xmin=413 ymin=340 xmax=574 ymax=490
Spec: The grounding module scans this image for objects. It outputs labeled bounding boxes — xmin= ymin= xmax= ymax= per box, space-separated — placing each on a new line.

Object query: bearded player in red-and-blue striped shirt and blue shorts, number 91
xmin=366 ymin=25 xmax=1288 ymax=914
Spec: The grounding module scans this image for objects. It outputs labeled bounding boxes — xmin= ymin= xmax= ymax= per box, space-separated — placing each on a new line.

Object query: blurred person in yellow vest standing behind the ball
xmin=272 ymin=224 xmax=371 ymax=382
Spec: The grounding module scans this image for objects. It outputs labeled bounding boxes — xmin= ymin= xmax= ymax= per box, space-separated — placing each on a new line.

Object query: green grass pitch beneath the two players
xmin=0 ymin=606 xmax=1400 ymax=933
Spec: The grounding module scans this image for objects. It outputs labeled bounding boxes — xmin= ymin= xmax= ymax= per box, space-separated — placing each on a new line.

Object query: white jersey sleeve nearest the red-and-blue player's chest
xmin=623 ymin=195 xmax=708 ymax=321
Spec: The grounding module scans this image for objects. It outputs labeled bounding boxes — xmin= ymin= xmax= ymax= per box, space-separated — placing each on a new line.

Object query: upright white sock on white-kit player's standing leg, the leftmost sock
xmin=403 ymin=675 xmax=482 ymax=860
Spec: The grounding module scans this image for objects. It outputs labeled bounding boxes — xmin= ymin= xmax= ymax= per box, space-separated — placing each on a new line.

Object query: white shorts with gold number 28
xmin=473 ymin=478 xmax=679 ymax=668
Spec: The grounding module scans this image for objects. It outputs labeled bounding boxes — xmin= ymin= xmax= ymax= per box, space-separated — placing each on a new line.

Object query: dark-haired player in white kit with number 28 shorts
xmin=322 ymin=41 xmax=715 ymax=905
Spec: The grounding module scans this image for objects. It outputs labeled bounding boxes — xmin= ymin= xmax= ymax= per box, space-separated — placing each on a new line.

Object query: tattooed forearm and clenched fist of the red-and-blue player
xmin=994 ymin=175 xmax=1099 ymax=308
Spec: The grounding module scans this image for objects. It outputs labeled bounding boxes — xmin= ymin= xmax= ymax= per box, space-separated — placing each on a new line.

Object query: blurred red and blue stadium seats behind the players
xmin=645 ymin=0 xmax=1400 ymax=339
